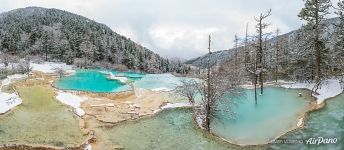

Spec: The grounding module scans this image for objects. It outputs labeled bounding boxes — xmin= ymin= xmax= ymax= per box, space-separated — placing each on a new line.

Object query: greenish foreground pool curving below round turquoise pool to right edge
xmin=90 ymin=94 xmax=344 ymax=150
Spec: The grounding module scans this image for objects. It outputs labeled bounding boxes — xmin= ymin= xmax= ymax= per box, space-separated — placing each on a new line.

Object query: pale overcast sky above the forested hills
xmin=0 ymin=0 xmax=338 ymax=59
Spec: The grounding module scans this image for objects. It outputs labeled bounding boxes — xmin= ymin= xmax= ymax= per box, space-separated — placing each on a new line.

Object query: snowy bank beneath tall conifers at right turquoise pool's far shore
xmin=281 ymin=79 xmax=343 ymax=104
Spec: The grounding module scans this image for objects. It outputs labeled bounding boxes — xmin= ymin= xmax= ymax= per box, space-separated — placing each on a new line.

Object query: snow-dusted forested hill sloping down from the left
xmin=0 ymin=7 xmax=187 ymax=73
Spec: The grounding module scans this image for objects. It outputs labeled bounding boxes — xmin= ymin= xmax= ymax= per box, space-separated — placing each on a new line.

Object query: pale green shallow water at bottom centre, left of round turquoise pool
xmin=98 ymin=109 xmax=243 ymax=150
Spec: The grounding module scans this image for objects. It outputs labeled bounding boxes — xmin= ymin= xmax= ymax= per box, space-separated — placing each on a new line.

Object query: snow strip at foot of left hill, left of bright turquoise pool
xmin=30 ymin=62 xmax=73 ymax=73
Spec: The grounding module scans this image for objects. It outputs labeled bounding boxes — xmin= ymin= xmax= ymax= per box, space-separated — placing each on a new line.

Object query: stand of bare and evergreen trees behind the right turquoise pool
xmin=179 ymin=0 xmax=344 ymax=132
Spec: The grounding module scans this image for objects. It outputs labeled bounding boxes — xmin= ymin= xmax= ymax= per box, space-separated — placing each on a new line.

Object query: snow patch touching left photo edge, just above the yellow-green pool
xmin=0 ymin=92 xmax=23 ymax=114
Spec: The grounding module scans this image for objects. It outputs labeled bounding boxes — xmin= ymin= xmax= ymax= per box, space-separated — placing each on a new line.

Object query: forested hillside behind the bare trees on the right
xmin=186 ymin=17 xmax=344 ymax=80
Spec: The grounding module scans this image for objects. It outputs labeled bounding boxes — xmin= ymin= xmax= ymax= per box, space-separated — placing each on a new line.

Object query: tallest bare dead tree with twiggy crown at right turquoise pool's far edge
xmin=255 ymin=9 xmax=271 ymax=94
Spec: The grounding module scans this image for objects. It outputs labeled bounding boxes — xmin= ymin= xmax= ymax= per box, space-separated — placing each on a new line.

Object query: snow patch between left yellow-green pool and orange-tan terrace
xmin=56 ymin=91 xmax=87 ymax=117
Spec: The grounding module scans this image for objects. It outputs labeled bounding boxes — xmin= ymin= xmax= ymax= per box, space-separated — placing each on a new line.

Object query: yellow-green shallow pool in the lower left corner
xmin=0 ymin=86 xmax=85 ymax=146
